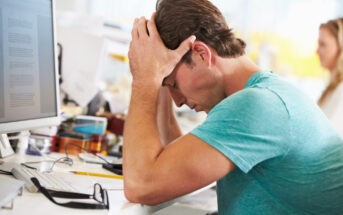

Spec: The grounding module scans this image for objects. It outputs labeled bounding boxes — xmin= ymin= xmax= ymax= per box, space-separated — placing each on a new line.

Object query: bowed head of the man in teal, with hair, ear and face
xmin=155 ymin=0 xmax=245 ymax=112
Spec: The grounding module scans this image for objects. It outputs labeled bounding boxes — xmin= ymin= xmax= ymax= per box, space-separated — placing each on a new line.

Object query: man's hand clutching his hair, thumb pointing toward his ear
xmin=129 ymin=13 xmax=195 ymax=85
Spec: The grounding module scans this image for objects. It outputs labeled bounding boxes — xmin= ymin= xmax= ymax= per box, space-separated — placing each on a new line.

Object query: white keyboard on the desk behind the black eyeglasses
xmin=12 ymin=166 xmax=78 ymax=192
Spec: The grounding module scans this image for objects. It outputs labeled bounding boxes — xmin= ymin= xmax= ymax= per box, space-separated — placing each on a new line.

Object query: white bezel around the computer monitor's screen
xmin=0 ymin=0 xmax=61 ymax=134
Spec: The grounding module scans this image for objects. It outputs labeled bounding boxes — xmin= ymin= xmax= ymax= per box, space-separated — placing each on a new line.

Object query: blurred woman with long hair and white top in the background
xmin=317 ymin=18 xmax=343 ymax=137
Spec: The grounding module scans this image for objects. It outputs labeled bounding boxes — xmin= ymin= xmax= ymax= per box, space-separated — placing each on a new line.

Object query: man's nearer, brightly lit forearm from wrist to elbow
xmin=123 ymin=82 xmax=163 ymax=183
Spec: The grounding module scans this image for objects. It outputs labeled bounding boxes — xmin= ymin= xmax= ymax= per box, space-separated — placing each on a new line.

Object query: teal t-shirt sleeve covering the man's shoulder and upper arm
xmin=190 ymin=88 xmax=290 ymax=173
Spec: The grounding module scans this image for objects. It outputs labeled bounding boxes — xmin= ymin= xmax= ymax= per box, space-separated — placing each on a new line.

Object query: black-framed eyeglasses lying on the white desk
xmin=31 ymin=177 xmax=109 ymax=210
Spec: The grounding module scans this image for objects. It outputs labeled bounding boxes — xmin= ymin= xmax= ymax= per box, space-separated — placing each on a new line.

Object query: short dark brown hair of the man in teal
xmin=155 ymin=0 xmax=246 ymax=64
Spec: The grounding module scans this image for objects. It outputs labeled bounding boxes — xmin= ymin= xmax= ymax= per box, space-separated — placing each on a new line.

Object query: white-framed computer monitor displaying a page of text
xmin=0 ymin=0 xmax=60 ymax=157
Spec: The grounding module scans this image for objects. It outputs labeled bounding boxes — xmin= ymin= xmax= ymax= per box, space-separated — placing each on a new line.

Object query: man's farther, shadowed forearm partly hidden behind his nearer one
xmin=157 ymin=87 xmax=182 ymax=146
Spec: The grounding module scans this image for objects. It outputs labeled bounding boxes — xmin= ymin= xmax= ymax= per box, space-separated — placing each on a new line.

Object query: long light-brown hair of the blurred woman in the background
xmin=318 ymin=18 xmax=343 ymax=105
